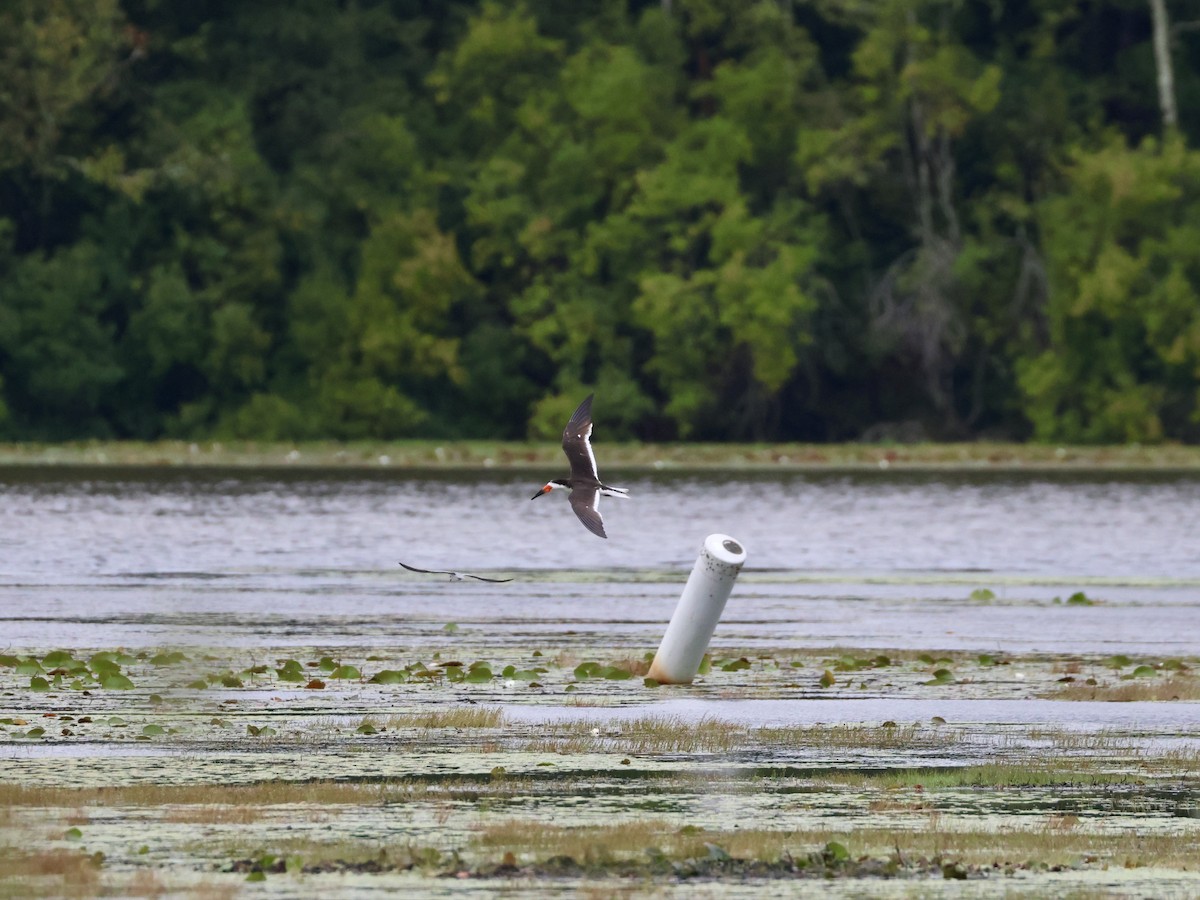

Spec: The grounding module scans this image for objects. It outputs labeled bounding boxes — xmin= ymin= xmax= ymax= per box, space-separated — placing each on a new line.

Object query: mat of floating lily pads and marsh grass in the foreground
xmin=0 ymin=634 xmax=1200 ymax=896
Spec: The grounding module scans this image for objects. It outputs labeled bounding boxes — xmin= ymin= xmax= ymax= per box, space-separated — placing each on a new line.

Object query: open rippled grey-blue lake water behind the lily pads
xmin=0 ymin=468 xmax=1200 ymax=655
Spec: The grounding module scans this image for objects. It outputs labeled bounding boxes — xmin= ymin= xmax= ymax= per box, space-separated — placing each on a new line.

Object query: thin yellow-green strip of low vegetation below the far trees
xmin=0 ymin=440 xmax=1200 ymax=472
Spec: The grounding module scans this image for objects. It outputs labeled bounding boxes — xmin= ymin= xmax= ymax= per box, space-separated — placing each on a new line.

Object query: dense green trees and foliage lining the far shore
xmin=0 ymin=0 xmax=1200 ymax=442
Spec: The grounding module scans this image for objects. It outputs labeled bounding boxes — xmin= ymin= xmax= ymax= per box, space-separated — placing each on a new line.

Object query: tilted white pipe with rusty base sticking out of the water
xmin=647 ymin=534 xmax=746 ymax=684
